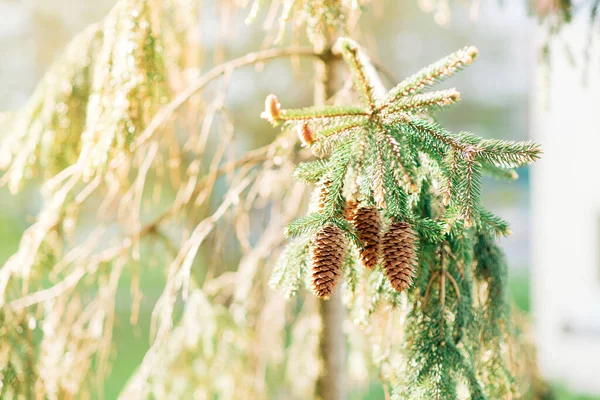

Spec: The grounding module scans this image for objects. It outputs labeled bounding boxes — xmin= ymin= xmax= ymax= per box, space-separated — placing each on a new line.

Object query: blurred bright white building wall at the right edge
xmin=531 ymin=11 xmax=600 ymax=394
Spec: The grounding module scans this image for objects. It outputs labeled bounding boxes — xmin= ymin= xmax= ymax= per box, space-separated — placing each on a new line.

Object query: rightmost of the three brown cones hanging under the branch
xmin=383 ymin=221 xmax=417 ymax=292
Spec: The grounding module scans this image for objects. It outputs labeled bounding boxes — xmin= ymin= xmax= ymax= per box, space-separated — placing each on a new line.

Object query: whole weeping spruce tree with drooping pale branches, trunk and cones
xmin=0 ymin=0 xmax=548 ymax=400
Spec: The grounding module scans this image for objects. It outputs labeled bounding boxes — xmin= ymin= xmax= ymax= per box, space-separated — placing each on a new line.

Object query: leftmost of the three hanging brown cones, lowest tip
xmin=312 ymin=225 xmax=346 ymax=298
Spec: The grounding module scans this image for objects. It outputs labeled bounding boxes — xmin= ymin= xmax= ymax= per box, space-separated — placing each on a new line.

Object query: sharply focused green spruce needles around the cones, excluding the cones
xmin=263 ymin=38 xmax=540 ymax=399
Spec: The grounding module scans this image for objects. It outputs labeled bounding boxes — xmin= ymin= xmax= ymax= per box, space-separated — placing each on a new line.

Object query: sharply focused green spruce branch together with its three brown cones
xmin=264 ymin=39 xmax=540 ymax=399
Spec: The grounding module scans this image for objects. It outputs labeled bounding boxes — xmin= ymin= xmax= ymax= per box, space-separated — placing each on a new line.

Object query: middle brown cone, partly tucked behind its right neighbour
xmin=349 ymin=207 xmax=381 ymax=269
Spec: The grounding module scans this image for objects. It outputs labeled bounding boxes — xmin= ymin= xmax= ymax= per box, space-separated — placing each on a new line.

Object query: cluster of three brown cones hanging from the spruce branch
xmin=311 ymin=202 xmax=417 ymax=298
